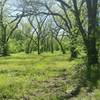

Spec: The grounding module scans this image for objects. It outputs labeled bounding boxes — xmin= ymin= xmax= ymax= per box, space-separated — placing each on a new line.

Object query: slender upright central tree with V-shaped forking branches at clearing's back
xmin=29 ymin=16 xmax=48 ymax=54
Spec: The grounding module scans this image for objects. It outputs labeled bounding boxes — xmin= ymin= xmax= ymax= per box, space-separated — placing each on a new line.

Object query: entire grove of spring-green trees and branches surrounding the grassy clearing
xmin=0 ymin=0 xmax=100 ymax=94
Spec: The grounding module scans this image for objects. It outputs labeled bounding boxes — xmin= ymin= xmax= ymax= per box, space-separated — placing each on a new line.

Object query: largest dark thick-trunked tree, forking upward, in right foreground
xmin=56 ymin=0 xmax=98 ymax=86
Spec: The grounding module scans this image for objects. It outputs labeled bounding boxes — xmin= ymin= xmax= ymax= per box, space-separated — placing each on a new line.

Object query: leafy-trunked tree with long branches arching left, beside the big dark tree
xmin=34 ymin=1 xmax=79 ymax=59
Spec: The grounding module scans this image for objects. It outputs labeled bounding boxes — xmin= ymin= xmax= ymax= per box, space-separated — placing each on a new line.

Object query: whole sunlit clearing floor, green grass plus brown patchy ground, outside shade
xmin=0 ymin=53 xmax=100 ymax=100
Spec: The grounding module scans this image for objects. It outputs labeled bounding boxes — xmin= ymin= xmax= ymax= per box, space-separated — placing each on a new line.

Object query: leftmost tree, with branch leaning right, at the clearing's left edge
xmin=0 ymin=0 xmax=23 ymax=56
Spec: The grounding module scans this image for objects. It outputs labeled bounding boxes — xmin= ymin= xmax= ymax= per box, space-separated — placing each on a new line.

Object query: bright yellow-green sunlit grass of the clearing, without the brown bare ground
xmin=0 ymin=53 xmax=68 ymax=100
